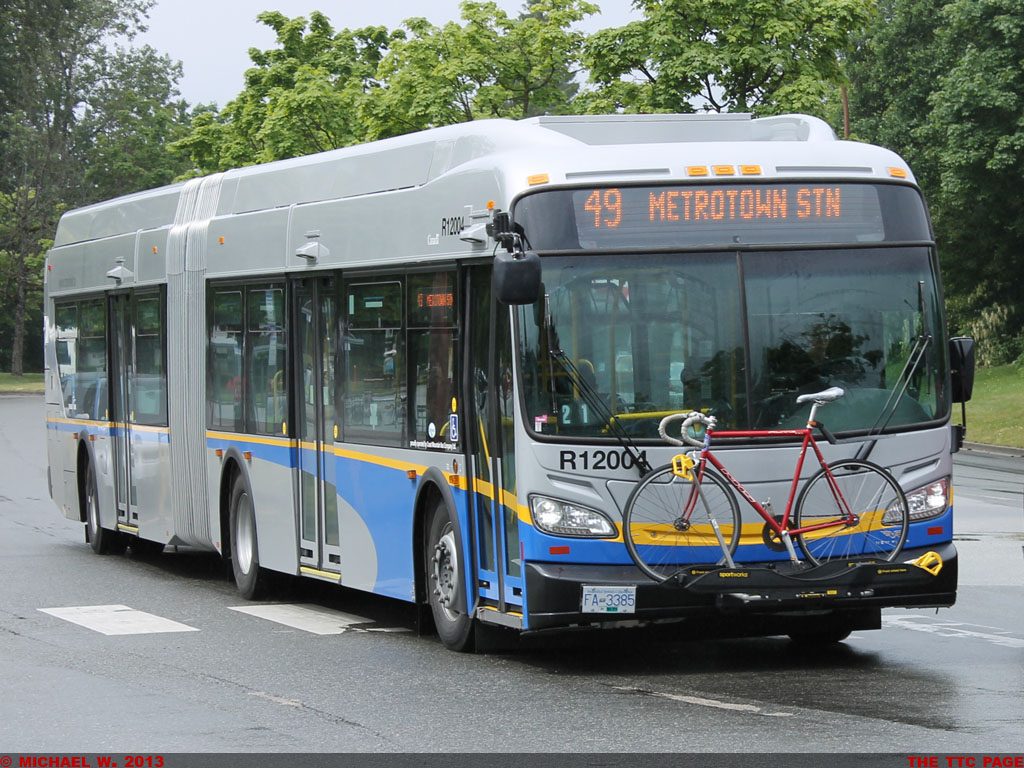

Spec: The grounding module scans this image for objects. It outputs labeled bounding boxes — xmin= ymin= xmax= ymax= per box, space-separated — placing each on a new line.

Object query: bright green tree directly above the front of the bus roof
xmin=584 ymin=0 xmax=873 ymax=115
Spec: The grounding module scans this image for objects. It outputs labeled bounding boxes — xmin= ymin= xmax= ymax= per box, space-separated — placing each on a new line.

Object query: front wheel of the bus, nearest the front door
xmin=423 ymin=502 xmax=473 ymax=651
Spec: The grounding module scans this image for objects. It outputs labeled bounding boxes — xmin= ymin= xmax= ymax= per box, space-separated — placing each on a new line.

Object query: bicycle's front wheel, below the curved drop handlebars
xmin=623 ymin=464 xmax=740 ymax=582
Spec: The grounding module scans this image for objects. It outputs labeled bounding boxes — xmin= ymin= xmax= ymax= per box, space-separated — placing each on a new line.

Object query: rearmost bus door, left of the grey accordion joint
xmin=110 ymin=293 xmax=138 ymax=532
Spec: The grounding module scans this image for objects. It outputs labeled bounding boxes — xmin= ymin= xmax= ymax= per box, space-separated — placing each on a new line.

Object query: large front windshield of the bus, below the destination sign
xmin=518 ymin=245 xmax=948 ymax=438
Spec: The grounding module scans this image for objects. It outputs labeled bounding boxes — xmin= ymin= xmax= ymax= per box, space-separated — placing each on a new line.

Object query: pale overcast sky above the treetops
xmin=135 ymin=0 xmax=640 ymax=106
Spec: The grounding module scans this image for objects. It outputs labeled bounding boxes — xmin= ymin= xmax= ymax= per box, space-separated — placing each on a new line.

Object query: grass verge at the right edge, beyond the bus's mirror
xmin=953 ymin=366 xmax=1024 ymax=447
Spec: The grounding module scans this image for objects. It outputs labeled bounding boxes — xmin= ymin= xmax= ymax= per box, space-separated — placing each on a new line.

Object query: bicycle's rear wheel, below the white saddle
xmin=794 ymin=459 xmax=910 ymax=565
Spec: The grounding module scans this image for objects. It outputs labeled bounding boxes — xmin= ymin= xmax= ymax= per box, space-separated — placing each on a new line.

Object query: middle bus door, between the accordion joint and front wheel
xmin=292 ymin=278 xmax=341 ymax=579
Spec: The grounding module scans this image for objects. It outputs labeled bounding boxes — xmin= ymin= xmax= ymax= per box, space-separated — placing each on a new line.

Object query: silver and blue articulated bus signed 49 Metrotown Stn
xmin=45 ymin=115 xmax=970 ymax=650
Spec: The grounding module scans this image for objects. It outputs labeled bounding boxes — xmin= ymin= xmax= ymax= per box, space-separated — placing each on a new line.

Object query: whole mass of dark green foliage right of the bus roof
xmin=849 ymin=0 xmax=1024 ymax=365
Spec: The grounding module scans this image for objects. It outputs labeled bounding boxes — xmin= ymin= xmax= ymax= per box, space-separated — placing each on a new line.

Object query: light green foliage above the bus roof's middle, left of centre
xmin=172 ymin=0 xmax=597 ymax=173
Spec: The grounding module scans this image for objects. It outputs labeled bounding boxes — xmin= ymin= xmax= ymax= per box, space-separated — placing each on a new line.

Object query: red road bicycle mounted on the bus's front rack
xmin=623 ymin=387 xmax=909 ymax=582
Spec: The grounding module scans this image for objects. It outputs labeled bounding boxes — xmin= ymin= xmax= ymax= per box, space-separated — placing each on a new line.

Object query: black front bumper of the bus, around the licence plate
xmin=525 ymin=542 xmax=957 ymax=635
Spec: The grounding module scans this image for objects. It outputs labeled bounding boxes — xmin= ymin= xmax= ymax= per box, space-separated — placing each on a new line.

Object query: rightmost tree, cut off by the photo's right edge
xmin=923 ymin=0 xmax=1024 ymax=362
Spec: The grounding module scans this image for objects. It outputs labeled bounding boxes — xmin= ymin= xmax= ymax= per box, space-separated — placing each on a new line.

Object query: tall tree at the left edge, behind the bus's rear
xmin=0 ymin=0 xmax=190 ymax=375
